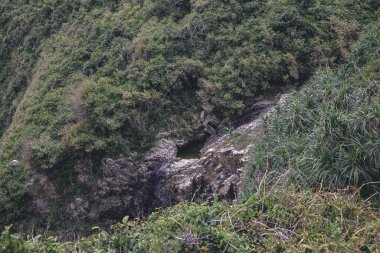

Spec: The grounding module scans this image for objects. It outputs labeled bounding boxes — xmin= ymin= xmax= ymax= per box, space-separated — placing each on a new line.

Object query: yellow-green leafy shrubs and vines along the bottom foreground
xmin=0 ymin=189 xmax=380 ymax=253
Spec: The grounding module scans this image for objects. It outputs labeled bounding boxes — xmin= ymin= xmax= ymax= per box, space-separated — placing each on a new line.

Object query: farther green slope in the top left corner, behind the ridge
xmin=0 ymin=0 xmax=118 ymax=135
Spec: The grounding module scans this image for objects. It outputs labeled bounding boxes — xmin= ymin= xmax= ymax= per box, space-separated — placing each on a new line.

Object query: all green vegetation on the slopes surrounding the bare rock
xmin=0 ymin=0 xmax=380 ymax=252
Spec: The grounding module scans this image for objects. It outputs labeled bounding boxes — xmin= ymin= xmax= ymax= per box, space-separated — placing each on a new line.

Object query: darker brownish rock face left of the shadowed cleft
xmin=70 ymin=156 xmax=154 ymax=220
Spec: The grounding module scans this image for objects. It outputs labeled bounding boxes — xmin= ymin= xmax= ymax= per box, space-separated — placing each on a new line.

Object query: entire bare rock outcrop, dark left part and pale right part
xmin=30 ymin=96 xmax=286 ymax=221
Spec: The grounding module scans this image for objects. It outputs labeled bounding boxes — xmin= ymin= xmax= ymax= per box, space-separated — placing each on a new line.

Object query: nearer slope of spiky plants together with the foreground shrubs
xmin=0 ymin=16 xmax=380 ymax=252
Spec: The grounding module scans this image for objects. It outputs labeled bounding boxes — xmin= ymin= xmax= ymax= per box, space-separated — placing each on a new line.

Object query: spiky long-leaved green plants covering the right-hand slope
xmin=242 ymin=23 xmax=380 ymax=198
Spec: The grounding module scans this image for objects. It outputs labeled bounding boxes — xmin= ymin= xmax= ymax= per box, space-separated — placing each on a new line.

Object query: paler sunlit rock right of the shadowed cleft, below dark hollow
xmin=150 ymin=95 xmax=287 ymax=206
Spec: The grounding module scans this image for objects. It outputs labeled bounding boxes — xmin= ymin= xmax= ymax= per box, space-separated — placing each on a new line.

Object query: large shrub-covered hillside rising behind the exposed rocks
xmin=0 ymin=0 xmax=379 ymax=229
